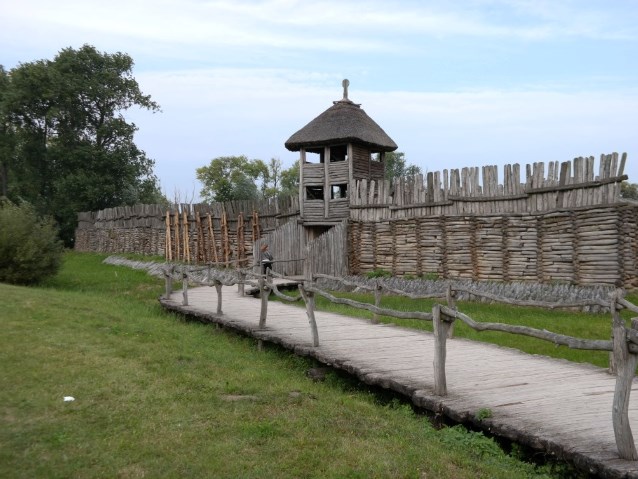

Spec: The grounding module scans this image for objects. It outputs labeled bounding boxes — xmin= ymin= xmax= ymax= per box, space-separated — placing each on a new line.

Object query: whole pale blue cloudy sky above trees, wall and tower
xmin=0 ymin=0 xmax=638 ymax=202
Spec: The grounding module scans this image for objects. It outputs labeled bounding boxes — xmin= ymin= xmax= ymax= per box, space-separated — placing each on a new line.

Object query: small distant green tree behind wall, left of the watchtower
xmin=196 ymin=155 xmax=269 ymax=203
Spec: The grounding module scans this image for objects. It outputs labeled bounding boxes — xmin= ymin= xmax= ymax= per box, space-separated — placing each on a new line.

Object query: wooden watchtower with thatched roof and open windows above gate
xmin=285 ymin=80 xmax=397 ymax=239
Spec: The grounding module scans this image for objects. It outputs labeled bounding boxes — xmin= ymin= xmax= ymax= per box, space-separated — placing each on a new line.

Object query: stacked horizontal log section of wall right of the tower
xmin=349 ymin=203 xmax=638 ymax=288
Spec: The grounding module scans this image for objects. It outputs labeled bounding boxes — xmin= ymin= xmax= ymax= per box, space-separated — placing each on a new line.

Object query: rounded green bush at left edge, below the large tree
xmin=0 ymin=199 xmax=62 ymax=285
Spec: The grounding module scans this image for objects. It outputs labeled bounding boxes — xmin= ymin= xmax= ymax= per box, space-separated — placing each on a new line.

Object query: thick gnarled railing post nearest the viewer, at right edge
xmin=611 ymin=293 xmax=638 ymax=461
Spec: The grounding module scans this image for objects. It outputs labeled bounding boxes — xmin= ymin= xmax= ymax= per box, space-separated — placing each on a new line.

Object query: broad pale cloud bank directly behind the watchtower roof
xmin=126 ymin=69 xmax=638 ymax=199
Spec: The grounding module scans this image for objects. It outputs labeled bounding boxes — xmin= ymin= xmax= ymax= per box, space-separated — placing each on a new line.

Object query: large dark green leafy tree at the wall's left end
xmin=0 ymin=45 xmax=162 ymax=245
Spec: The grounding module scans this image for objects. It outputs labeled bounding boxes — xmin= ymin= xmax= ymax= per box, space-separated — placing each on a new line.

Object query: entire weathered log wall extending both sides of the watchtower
xmin=75 ymin=154 xmax=638 ymax=288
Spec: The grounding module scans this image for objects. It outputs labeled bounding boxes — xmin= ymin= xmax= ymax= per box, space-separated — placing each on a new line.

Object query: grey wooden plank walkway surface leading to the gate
xmin=160 ymin=286 xmax=638 ymax=478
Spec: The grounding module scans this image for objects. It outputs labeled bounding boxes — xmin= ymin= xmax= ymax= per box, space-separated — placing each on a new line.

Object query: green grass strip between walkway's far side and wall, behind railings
xmin=278 ymin=293 xmax=638 ymax=367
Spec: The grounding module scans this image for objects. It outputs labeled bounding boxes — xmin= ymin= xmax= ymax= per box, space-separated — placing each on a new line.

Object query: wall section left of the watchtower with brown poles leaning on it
xmin=75 ymin=197 xmax=299 ymax=265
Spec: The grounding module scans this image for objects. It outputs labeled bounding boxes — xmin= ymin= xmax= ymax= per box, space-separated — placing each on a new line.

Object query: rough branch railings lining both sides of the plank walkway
xmin=165 ymin=265 xmax=638 ymax=461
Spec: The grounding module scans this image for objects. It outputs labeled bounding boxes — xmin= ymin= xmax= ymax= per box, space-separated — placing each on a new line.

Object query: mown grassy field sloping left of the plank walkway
xmin=0 ymin=253 xmax=570 ymax=478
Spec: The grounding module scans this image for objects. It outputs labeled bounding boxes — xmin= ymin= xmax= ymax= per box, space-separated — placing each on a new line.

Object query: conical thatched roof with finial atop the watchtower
xmin=286 ymin=92 xmax=397 ymax=151
